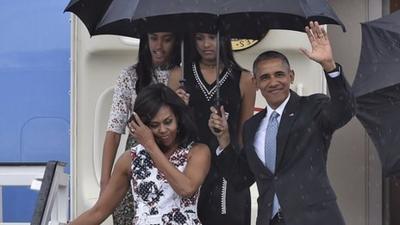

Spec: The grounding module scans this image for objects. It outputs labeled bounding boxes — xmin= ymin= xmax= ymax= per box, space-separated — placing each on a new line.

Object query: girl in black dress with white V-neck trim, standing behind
xmin=169 ymin=33 xmax=256 ymax=225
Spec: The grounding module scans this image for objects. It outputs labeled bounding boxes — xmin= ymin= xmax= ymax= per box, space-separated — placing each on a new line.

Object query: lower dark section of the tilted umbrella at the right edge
xmin=356 ymin=83 xmax=400 ymax=176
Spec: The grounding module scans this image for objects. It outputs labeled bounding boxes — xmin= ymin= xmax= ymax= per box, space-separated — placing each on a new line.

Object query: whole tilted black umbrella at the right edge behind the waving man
xmin=352 ymin=11 xmax=400 ymax=176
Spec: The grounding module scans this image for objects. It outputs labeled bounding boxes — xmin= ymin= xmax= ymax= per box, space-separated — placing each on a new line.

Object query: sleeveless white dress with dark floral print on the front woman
xmin=131 ymin=144 xmax=201 ymax=225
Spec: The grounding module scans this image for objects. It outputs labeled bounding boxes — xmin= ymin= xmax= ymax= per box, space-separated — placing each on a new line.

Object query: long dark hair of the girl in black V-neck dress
xmin=184 ymin=33 xmax=244 ymax=74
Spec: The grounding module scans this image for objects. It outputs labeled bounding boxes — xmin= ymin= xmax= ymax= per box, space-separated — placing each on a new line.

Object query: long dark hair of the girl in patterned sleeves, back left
xmin=135 ymin=34 xmax=181 ymax=93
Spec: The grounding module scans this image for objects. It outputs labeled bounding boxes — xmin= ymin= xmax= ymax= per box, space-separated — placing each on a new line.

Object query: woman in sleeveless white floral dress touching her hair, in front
xmin=71 ymin=84 xmax=211 ymax=225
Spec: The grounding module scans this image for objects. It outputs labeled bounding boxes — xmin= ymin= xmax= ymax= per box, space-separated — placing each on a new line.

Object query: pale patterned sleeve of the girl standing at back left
xmin=107 ymin=66 xmax=137 ymax=134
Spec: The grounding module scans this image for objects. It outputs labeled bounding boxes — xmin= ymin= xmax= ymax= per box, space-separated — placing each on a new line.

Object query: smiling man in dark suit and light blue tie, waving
xmin=209 ymin=22 xmax=354 ymax=225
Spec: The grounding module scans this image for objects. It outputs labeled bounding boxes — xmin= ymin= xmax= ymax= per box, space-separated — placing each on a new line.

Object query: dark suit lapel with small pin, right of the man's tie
xmin=276 ymin=91 xmax=300 ymax=170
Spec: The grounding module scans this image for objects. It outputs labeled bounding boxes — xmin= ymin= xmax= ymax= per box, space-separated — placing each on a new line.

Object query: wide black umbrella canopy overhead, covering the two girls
xmin=65 ymin=0 xmax=345 ymax=39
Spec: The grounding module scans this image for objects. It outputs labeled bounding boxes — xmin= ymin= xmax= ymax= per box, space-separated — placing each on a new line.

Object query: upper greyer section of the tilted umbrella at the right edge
xmin=353 ymin=11 xmax=400 ymax=96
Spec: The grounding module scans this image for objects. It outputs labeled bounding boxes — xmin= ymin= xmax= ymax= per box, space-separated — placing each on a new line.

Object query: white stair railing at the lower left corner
xmin=0 ymin=161 xmax=69 ymax=225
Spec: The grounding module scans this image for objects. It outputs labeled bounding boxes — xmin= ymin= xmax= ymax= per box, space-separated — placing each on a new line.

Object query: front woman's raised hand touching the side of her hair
xmin=128 ymin=112 xmax=157 ymax=151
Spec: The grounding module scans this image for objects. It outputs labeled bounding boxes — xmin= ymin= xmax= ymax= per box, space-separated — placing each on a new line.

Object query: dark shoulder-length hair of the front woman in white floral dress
xmin=134 ymin=83 xmax=198 ymax=147
